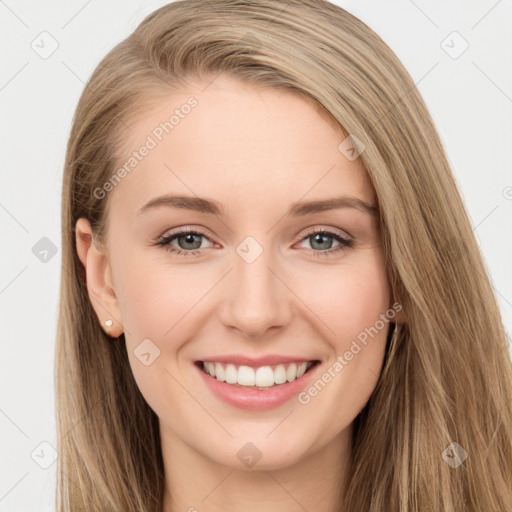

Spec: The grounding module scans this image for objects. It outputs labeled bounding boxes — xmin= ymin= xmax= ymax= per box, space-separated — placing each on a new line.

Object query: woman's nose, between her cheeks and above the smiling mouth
xmin=219 ymin=246 xmax=294 ymax=339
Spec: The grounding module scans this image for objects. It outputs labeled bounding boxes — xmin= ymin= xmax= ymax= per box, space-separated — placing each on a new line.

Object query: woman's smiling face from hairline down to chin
xmin=79 ymin=76 xmax=394 ymax=469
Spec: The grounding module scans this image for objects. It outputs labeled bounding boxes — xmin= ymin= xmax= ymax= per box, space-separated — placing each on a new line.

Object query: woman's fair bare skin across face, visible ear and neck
xmin=76 ymin=76 xmax=396 ymax=512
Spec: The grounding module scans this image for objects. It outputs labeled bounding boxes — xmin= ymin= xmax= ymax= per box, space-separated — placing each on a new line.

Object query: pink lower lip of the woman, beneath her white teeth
xmin=194 ymin=362 xmax=320 ymax=411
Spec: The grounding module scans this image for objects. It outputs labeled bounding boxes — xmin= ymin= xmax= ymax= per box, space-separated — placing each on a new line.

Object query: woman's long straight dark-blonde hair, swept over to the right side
xmin=55 ymin=0 xmax=512 ymax=512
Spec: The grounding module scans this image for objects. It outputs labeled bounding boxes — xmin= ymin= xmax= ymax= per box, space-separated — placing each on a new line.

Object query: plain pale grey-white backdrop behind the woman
xmin=0 ymin=0 xmax=512 ymax=512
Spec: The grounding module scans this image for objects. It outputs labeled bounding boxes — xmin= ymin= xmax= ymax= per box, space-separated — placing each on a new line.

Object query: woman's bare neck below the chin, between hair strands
xmin=160 ymin=425 xmax=352 ymax=512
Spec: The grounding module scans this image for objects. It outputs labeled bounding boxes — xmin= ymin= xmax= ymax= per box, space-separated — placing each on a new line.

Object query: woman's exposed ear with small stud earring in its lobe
xmin=75 ymin=218 xmax=123 ymax=338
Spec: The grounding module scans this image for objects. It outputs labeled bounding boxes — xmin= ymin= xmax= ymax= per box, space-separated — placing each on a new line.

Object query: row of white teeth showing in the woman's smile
xmin=203 ymin=361 xmax=313 ymax=388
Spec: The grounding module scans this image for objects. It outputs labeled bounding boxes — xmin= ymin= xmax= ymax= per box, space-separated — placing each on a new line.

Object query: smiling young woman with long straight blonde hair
xmin=56 ymin=0 xmax=512 ymax=512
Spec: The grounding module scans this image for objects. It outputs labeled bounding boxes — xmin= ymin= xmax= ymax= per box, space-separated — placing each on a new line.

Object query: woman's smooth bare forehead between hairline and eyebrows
xmin=111 ymin=76 xmax=375 ymax=218
